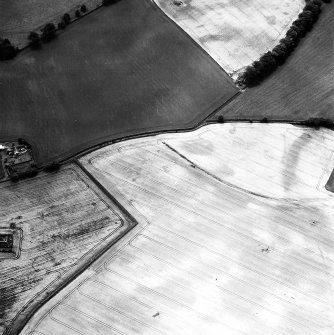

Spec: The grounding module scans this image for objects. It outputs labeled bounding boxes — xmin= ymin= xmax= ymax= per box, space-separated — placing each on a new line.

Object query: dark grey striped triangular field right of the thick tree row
xmin=216 ymin=3 xmax=334 ymax=120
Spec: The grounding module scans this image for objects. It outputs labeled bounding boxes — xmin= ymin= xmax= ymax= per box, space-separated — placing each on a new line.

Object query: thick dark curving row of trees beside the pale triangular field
xmin=237 ymin=0 xmax=331 ymax=87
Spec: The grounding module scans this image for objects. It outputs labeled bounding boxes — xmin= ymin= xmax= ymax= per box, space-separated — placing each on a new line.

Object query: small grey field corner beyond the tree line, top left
xmin=0 ymin=0 xmax=102 ymax=48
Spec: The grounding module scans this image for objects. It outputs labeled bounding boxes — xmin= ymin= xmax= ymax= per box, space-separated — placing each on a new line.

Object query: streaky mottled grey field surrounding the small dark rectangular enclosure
xmin=0 ymin=164 xmax=135 ymax=334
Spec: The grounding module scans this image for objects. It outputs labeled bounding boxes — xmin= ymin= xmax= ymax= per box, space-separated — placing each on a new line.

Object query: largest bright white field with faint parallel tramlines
xmin=22 ymin=124 xmax=334 ymax=335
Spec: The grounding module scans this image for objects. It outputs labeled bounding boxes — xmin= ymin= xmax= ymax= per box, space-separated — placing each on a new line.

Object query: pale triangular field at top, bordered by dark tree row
xmin=152 ymin=0 xmax=305 ymax=74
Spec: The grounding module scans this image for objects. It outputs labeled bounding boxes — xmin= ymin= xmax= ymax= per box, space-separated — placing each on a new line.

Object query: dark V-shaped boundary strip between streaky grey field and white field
xmin=3 ymin=159 xmax=138 ymax=335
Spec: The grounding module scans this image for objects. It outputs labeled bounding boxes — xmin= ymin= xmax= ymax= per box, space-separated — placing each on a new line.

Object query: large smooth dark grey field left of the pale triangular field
xmin=0 ymin=0 xmax=239 ymax=164
